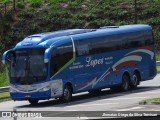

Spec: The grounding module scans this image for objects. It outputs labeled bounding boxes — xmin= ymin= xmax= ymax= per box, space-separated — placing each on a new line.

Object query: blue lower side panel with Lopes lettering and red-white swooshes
xmin=51 ymin=47 xmax=155 ymax=93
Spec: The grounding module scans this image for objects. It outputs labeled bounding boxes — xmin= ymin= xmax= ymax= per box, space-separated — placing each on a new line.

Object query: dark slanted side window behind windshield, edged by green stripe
xmin=50 ymin=42 xmax=73 ymax=76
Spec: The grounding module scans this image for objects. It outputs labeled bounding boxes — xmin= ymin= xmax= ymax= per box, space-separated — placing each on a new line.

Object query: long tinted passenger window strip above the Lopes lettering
xmin=75 ymin=31 xmax=153 ymax=56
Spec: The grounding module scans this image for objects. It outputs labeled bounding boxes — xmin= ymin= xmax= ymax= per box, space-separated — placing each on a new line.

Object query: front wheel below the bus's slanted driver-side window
xmin=60 ymin=85 xmax=72 ymax=102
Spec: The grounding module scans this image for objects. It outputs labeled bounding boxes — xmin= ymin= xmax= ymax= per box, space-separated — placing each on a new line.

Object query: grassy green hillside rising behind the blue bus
xmin=0 ymin=0 xmax=160 ymax=86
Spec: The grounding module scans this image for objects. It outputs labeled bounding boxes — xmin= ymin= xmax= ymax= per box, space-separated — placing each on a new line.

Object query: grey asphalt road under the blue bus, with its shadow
xmin=0 ymin=75 xmax=160 ymax=120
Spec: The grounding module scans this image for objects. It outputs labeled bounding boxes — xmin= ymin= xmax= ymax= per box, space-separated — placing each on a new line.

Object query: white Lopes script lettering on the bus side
xmin=86 ymin=56 xmax=104 ymax=67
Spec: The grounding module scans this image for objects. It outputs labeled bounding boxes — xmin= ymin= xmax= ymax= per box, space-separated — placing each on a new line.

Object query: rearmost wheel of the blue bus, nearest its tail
xmin=130 ymin=72 xmax=140 ymax=89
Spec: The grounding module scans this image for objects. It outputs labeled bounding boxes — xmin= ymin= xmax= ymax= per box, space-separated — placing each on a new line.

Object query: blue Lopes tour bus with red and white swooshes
xmin=2 ymin=24 xmax=157 ymax=104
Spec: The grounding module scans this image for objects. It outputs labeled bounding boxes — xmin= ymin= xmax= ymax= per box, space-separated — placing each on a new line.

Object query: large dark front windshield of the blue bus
xmin=10 ymin=48 xmax=47 ymax=84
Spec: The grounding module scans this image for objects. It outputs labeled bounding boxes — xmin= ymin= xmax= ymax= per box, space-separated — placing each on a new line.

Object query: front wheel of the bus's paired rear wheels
xmin=121 ymin=74 xmax=130 ymax=91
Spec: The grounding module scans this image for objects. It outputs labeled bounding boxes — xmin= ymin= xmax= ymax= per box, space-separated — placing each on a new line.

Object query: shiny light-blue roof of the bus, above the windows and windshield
xmin=15 ymin=24 xmax=152 ymax=48
